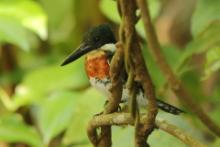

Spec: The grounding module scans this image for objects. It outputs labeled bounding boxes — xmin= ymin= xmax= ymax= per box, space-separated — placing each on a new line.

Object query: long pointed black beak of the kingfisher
xmin=61 ymin=43 xmax=93 ymax=66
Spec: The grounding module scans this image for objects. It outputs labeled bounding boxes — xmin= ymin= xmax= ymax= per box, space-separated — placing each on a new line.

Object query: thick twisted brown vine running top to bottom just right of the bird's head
xmin=119 ymin=0 xmax=157 ymax=147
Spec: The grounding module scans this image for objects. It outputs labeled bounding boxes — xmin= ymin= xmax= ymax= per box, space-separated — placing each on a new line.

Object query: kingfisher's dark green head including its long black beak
xmin=61 ymin=24 xmax=116 ymax=66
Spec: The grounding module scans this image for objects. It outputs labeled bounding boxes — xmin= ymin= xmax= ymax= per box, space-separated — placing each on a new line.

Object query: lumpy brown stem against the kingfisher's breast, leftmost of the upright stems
xmin=87 ymin=43 xmax=124 ymax=147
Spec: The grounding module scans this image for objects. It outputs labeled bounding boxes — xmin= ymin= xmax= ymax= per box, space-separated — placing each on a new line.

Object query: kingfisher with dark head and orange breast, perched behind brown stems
xmin=61 ymin=24 xmax=183 ymax=115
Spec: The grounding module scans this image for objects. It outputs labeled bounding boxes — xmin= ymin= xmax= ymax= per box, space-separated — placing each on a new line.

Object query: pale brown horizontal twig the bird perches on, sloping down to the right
xmin=90 ymin=113 xmax=205 ymax=147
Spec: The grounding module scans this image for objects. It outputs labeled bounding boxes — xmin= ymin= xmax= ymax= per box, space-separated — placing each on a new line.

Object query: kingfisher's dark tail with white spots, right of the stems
xmin=157 ymin=99 xmax=184 ymax=115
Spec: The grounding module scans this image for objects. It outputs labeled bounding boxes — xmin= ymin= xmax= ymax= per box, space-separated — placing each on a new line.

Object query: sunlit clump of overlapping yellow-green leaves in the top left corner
xmin=0 ymin=0 xmax=47 ymax=50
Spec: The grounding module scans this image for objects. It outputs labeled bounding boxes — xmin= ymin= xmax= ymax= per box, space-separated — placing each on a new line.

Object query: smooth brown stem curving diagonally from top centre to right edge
xmin=137 ymin=0 xmax=220 ymax=136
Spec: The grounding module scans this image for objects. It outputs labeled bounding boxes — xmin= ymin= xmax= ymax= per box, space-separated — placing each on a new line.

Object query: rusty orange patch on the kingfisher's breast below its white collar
xmin=85 ymin=52 xmax=110 ymax=79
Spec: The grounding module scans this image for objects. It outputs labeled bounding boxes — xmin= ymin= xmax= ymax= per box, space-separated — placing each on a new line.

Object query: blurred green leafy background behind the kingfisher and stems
xmin=0 ymin=0 xmax=220 ymax=147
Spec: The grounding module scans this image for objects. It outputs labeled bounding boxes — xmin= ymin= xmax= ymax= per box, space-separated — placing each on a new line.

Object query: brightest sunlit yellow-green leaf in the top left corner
xmin=0 ymin=0 xmax=47 ymax=39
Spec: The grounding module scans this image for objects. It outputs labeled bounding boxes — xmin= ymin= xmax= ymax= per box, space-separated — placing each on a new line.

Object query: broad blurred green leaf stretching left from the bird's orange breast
xmin=13 ymin=59 xmax=88 ymax=106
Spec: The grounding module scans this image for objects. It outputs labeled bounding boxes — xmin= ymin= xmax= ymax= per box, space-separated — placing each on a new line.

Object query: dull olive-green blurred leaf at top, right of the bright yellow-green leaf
xmin=39 ymin=0 xmax=73 ymax=43
